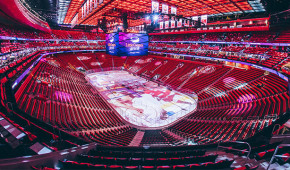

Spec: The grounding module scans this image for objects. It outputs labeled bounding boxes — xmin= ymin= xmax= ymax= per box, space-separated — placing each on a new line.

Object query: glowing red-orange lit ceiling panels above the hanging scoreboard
xmin=58 ymin=0 xmax=265 ymax=25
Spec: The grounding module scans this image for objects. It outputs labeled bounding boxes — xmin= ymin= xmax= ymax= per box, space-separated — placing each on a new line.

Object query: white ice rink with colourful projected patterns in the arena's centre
xmin=86 ymin=70 xmax=198 ymax=127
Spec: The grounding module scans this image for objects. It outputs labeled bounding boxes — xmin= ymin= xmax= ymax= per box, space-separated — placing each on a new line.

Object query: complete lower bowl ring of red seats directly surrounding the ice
xmin=10 ymin=53 xmax=290 ymax=146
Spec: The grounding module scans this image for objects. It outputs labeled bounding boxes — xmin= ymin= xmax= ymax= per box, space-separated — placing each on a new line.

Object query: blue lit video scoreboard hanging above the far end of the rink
xmin=106 ymin=32 xmax=149 ymax=56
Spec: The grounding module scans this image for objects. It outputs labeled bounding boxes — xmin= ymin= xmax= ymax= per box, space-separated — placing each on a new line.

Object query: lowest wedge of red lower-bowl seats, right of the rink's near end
xmin=169 ymin=119 xmax=272 ymax=144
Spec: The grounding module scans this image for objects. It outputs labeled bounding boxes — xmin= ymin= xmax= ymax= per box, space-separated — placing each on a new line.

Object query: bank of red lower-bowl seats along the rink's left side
xmin=15 ymin=62 xmax=122 ymax=131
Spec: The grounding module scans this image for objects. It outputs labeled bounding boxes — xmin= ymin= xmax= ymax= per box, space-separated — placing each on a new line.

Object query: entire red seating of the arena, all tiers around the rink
xmin=0 ymin=18 xmax=290 ymax=170
